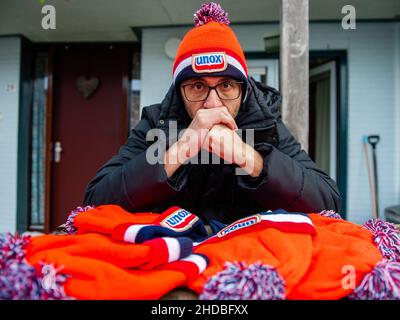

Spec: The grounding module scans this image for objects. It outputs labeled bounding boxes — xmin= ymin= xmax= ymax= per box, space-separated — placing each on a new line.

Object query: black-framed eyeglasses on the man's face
xmin=182 ymin=80 xmax=243 ymax=102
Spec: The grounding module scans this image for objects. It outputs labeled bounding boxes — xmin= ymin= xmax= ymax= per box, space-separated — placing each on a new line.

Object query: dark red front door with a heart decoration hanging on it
xmin=50 ymin=44 xmax=131 ymax=230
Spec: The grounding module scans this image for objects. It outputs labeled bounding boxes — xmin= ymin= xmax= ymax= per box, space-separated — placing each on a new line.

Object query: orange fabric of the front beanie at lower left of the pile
xmin=30 ymin=250 xmax=186 ymax=300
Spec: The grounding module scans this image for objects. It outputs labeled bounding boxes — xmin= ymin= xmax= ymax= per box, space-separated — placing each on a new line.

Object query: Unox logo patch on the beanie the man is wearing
xmin=192 ymin=52 xmax=228 ymax=73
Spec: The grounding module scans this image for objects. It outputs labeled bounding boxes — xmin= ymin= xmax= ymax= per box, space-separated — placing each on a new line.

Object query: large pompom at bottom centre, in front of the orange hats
xmin=199 ymin=262 xmax=285 ymax=300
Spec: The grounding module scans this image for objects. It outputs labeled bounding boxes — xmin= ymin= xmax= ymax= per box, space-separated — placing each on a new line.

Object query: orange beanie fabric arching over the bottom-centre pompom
xmin=189 ymin=221 xmax=312 ymax=293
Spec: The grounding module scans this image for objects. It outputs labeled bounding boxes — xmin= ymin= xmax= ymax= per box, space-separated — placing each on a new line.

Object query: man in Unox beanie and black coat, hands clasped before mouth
xmin=84 ymin=3 xmax=340 ymax=223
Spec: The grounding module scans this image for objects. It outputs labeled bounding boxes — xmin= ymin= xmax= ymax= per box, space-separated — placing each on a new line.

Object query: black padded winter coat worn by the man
xmin=84 ymin=79 xmax=340 ymax=223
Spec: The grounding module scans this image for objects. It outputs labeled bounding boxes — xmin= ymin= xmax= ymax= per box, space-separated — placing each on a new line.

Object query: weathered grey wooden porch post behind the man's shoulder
xmin=280 ymin=0 xmax=309 ymax=151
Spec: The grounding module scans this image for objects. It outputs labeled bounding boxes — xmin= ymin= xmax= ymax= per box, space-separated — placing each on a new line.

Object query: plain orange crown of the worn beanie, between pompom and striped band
xmin=174 ymin=21 xmax=247 ymax=72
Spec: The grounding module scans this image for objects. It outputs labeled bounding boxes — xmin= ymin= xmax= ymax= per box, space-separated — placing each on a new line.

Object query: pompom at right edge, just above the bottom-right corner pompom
xmin=363 ymin=219 xmax=400 ymax=262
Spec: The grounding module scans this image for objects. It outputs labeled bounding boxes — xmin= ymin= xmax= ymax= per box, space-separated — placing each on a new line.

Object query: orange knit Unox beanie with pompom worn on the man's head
xmin=173 ymin=2 xmax=248 ymax=91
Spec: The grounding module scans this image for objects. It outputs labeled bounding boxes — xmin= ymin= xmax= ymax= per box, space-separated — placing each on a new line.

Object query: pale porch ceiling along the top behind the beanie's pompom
xmin=0 ymin=0 xmax=400 ymax=42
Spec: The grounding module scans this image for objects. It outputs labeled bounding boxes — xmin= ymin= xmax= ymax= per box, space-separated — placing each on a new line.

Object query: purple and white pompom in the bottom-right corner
xmin=348 ymin=260 xmax=400 ymax=300
